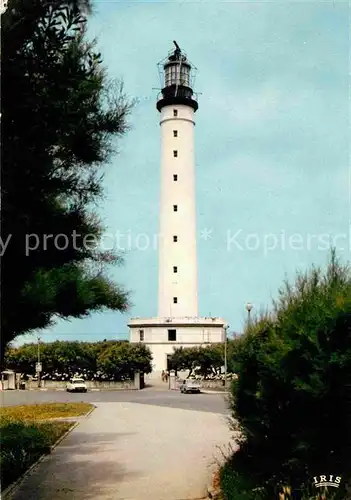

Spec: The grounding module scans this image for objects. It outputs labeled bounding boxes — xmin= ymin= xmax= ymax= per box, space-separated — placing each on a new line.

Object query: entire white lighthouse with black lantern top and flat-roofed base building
xmin=129 ymin=42 xmax=224 ymax=376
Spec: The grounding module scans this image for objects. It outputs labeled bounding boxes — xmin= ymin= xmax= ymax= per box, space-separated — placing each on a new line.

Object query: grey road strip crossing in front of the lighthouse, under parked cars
xmin=0 ymin=388 xmax=228 ymax=414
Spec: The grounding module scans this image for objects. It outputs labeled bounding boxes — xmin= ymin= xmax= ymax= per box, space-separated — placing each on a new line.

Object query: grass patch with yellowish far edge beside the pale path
xmin=0 ymin=403 xmax=93 ymax=490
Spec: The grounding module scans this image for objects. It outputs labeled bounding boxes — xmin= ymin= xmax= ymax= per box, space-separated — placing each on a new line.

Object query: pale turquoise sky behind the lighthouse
xmin=17 ymin=0 xmax=351 ymax=343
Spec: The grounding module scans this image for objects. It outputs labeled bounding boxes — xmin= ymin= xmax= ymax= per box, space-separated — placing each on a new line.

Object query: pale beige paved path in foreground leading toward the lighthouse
xmin=5 ymin=402 xmax=235 ymax=500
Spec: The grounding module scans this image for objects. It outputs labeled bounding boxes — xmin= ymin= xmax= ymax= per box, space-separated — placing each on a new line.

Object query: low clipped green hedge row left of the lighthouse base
xmin=5 ymin=341 xmax=152 ymax=380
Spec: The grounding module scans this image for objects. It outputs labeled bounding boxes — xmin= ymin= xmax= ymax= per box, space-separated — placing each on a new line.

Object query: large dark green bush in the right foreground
xmin=228 ymin=252 xmax=351 ymax=499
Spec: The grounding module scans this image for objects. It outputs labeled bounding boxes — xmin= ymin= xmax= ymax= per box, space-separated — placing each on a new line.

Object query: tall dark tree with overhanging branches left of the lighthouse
xmin=1 ymin=0 xmax=131 ymax=360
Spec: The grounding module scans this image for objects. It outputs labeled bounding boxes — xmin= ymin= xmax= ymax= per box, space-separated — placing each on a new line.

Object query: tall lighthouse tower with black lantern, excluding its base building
xmin=157 ymin=42 xmax=198 ymax=317
